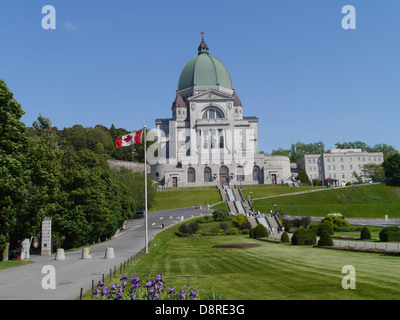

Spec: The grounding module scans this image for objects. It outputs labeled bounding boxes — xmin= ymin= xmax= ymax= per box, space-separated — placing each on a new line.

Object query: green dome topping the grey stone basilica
xmin=178 ymin=39 xmax=233 ymax=90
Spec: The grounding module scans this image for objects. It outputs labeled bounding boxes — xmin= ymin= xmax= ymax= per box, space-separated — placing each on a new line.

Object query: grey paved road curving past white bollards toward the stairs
xmin=0 ymin=208 xmax=212 ymax=300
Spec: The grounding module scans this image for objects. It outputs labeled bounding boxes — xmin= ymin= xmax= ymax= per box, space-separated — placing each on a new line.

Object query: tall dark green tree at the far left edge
xmin=0 ymin=79 xmax=29 ymax=260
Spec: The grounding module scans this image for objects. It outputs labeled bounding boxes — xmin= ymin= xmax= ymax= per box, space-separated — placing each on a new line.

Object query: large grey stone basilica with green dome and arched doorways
xmin=151 ymin=32 xmax=292 ymax=187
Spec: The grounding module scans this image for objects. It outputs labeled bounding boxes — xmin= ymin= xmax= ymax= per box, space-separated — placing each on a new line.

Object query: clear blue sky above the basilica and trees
xmin=0 ymin=0 xmax=400 ymax=153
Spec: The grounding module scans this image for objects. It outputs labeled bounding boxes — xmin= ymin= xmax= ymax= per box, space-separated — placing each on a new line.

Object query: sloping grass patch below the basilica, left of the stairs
xmin=151 ymin=187 xmax=222 ymax=211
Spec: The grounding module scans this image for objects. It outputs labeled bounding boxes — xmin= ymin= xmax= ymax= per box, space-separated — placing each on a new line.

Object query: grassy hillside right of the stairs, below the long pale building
xmin=253 ymin=184 xmax=400 ymax=218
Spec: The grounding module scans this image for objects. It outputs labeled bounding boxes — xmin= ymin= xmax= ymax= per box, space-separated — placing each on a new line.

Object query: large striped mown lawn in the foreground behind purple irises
xmin=86 ymin=219 xmax=400 ymax=300
